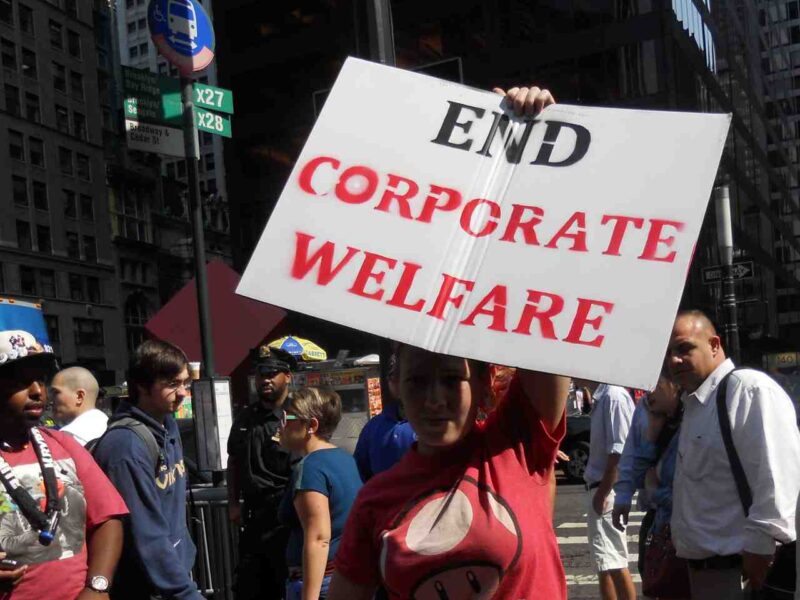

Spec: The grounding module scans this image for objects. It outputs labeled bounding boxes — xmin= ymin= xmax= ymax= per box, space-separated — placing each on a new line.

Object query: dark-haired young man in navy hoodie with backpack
xmin=93 ymin=341 xmax=203 ymax=600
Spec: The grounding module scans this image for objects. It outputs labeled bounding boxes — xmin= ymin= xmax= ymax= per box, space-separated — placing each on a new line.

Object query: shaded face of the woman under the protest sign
xmin=398 ymin=346 xmax=489 ymax=454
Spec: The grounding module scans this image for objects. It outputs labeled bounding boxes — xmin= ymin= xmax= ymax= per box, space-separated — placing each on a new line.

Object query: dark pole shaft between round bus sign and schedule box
xmin=181 ymin=77 xmax=215 ymax=377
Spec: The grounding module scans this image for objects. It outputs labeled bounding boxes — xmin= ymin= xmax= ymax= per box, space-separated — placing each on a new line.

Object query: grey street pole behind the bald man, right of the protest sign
xmin=714 ymin=184 xmax=741 ymax=364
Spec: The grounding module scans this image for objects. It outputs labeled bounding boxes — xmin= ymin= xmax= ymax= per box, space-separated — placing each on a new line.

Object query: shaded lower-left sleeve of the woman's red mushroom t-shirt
xmin=335 ymin=484 xmax=381 ymax=586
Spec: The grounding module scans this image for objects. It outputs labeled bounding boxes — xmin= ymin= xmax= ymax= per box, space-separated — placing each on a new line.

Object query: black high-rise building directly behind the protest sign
xmin=215 ymin=0 xmax=800 ymax=362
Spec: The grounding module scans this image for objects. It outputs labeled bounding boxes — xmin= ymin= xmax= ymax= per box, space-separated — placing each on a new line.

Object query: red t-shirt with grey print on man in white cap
xmin=0 ymin=428 xmax=128 ymax=600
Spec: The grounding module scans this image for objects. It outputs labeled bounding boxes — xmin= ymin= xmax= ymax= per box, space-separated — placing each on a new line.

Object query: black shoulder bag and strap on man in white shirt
xmin=717 ymin=367 xmax=797 ymax=600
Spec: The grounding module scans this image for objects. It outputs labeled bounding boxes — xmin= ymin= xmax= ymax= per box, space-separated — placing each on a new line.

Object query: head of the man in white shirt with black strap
xmin=667 ymin=310 xmax=726 ymax=393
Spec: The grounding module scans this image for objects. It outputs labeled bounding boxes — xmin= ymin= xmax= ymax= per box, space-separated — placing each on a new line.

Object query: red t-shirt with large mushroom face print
xmin=336 ymin=379 xmax=567 ymax=600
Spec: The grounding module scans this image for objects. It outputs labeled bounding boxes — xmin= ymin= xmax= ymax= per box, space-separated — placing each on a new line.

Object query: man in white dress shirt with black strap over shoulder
xmin=667 ymin=311 xmax=800 ymax=600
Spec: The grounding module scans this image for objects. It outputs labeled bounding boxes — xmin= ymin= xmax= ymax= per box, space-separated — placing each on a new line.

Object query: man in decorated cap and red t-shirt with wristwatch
xmin=0 ymin=299 xmax=128 ymax=600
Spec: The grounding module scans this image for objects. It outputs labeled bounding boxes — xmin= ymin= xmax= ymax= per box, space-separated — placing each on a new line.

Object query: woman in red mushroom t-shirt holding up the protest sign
xmin=328 ymin=88 xmax=569 ymax=600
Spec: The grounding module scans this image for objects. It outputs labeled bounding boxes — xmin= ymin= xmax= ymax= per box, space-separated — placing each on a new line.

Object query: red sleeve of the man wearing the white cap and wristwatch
xmin=48 ymin=431 xmax=128 ymax=532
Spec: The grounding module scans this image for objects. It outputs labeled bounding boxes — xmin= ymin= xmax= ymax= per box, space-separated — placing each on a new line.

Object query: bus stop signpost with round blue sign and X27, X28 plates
xmin=148 ymin=0 xmax=233 ymax=482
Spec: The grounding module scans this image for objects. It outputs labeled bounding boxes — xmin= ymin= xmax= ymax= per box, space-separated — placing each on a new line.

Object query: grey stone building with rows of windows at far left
xmin=0 ymin=0 xmax=126 ymax=383
